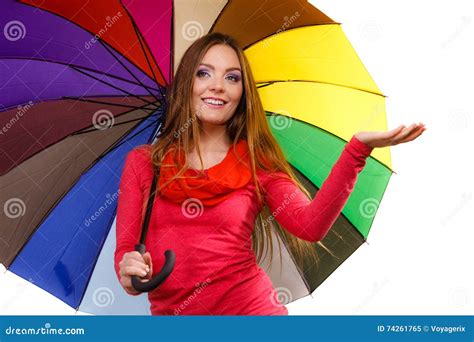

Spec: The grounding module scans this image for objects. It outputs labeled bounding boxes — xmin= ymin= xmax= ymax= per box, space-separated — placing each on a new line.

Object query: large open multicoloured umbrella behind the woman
xmin=0 ymin=0 xmax=392 ymax=314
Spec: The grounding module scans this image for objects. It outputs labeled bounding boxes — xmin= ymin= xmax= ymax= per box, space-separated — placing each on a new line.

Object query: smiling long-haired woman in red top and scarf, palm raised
xmin=115 ymin=33 xmax=425 ymax=315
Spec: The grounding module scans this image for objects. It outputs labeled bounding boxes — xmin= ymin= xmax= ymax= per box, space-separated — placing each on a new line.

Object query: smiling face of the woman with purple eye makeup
xmin=193 ymin=44 xmax=243 ymax=125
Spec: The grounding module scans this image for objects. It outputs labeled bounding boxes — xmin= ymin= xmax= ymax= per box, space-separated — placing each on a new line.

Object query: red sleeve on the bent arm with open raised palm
xmin=262 ymin=136 xmax=373 ymax=242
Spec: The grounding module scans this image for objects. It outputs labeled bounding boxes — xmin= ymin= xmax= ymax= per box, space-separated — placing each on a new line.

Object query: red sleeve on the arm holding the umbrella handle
xmin=114 ymin=150 xmax=147 ymax=294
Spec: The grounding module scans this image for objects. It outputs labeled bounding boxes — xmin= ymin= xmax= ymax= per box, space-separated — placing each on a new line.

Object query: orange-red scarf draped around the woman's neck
xmin=158 ymin=140 xmax=252 ymax=206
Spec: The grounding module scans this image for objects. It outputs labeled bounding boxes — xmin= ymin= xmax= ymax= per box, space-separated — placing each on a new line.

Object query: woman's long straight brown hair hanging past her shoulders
xmin=151 ymin=33 xmax=317 ymax=270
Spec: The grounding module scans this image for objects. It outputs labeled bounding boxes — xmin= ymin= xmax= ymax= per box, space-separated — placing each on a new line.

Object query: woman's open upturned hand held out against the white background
xmin=355 ymin=123 xmax=426 ymax=147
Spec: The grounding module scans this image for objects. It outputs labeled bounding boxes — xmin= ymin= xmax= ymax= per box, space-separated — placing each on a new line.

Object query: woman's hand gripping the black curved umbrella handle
xmin=119 ymin=251 xmax=153 ymax=295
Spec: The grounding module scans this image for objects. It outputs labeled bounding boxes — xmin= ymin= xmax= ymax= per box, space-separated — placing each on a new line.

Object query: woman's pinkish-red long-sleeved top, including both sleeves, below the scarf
xmin=115 ymin=136 xmax=373 ymax=315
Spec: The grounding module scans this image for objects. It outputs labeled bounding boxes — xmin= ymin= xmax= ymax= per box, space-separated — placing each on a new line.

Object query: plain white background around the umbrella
xmin=0 ymin=0 xmax=474 ymax=315
